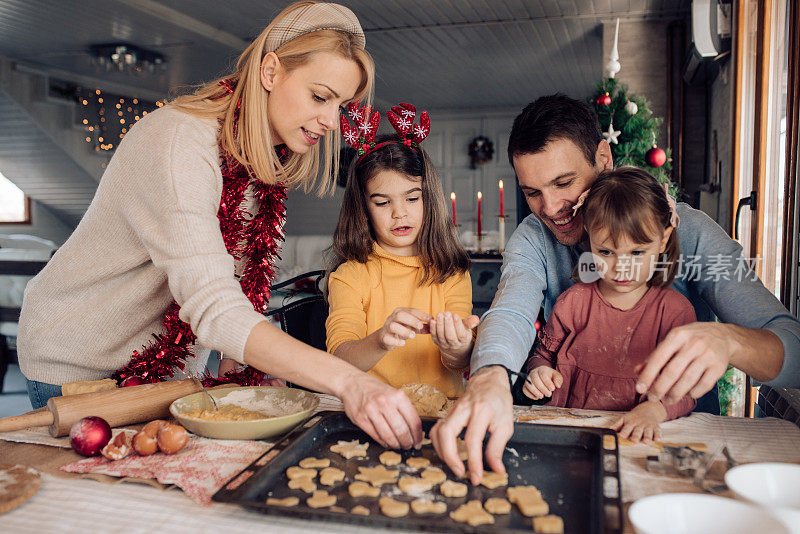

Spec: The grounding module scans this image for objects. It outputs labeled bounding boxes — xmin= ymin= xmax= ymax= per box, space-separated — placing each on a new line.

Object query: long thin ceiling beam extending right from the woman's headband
xmin=364 ymin=9 xmax=689 ymax=34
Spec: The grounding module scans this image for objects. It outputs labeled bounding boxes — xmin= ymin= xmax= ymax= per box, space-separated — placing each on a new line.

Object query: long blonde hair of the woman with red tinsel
xmin=172 ymin=1 xmax=375 ymax=196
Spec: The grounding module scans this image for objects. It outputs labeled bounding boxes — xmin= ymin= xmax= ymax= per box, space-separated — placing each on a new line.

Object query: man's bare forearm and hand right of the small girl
xmin=636 ymin=322 xmax=783 ymax=404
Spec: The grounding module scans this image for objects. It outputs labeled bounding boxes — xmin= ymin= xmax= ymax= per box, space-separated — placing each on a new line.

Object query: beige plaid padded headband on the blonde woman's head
xmin=266 ymin=2 xmax=367 ymax=52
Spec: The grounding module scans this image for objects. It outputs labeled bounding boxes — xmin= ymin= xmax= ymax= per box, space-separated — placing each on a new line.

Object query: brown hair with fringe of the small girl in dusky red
xmin=581 ymin=166 xmax=680 ymax=287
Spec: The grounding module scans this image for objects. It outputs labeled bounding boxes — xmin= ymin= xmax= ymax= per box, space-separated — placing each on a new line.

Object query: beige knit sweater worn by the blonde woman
xmin=17 ymin=106 xmax=265 ymax=385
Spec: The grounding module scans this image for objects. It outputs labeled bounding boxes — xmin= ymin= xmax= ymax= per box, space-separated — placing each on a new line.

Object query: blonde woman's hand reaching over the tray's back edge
xmin=339 ymin=373 xmax=422 ymax=449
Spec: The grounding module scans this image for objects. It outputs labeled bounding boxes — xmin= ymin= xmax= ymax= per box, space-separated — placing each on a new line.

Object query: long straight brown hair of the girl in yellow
xmin=328 ymin=136 xmax=470 ymax=286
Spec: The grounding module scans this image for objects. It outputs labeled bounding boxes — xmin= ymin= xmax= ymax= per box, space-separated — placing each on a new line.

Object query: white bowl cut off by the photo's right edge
xmin=725 ymin=462 xmax=800 ymax=533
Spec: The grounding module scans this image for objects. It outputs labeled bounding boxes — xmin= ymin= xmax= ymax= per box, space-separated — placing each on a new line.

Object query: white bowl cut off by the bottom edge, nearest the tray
xmin=628 ymin=493 xmax=789 ymax=534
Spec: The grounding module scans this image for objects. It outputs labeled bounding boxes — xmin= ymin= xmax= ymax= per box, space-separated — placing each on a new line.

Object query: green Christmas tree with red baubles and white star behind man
xmin=590 ymin=76 xmax=678 ymax=197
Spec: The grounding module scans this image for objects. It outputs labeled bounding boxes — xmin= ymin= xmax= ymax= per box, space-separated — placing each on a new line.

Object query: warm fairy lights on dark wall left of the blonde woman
xmin=75 ymin=87 xmax=164 ymax=152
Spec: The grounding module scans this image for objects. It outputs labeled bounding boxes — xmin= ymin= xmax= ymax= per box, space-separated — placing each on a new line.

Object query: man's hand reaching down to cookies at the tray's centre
xmin=430 ymin=366 xmax=514 ymax=484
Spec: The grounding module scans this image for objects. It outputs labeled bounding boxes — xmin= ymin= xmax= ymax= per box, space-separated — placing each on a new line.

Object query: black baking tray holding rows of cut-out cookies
xmin=213 ymin=412 xmax=622 ymax=534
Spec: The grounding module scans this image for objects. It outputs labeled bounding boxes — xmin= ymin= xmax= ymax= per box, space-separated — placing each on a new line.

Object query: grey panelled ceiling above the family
xmin=0 ymin=0 xmax=690 ymax=109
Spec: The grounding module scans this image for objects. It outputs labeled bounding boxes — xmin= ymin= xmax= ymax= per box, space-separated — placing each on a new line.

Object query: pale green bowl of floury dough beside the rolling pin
xmin=169 ymin=386 xmax=319 ymax=440
